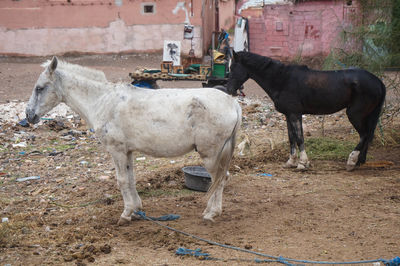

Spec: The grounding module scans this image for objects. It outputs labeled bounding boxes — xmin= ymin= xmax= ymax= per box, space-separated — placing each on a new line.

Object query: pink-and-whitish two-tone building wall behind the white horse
xmin=0 ymin=0 xmax=208 ymax=56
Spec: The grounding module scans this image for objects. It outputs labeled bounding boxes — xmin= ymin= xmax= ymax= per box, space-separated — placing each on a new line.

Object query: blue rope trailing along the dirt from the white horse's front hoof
xmin=135 ymin=211 xmax=400 ymax=266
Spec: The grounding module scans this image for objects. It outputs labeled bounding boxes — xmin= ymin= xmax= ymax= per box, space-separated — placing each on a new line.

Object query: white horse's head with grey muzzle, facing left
xmin=25 ymin=57 xmax=61 ymax=124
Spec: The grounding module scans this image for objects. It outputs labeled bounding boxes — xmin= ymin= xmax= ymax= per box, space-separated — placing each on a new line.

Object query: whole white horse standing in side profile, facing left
xmin=26 ymin=57 xmax=242 ymax=225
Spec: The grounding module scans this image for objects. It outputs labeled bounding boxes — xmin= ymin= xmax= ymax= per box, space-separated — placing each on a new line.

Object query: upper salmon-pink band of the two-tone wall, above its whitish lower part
xmin=0 ymin=0 xmax=202 ymax=30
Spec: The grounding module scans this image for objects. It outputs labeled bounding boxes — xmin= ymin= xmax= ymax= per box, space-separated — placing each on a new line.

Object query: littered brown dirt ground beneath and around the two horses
xmin=0 ymin=55 xmax=400 ymax=265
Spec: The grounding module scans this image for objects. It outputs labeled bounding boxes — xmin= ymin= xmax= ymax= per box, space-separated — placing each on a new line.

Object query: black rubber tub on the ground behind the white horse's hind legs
xmin=182 ymin=166 xmax=211 ymax=192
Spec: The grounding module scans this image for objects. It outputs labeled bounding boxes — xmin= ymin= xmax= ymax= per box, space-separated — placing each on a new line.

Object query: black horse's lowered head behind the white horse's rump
xmin=226 ymin=51 xmax=249 ymax=96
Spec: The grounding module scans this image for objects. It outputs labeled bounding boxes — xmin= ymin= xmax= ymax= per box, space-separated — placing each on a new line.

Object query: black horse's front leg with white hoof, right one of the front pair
xmin=286 ymin=114 xmax=310 ymax=170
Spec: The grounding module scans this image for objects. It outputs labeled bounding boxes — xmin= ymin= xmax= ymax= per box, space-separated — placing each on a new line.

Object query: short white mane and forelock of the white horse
xmin=41 ymin=60 xmax=108 ymax=82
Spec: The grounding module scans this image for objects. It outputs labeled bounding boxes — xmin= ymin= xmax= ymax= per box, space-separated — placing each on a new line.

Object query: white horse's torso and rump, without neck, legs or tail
xmin=102 ymin=88 xmax=241 ymax=157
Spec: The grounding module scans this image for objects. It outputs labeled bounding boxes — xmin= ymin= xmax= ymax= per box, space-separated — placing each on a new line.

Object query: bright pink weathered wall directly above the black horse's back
xmin=241 ymin=0 xmax=357 ymax=59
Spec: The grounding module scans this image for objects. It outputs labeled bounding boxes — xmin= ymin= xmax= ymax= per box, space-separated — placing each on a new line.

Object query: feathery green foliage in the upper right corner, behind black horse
xmin=323 ymin=0 xmax=400 ymax=72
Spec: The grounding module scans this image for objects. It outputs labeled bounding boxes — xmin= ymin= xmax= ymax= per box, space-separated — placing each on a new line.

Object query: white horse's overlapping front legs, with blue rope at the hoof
xmin=110 ymin=150 xmax=142 ymax=225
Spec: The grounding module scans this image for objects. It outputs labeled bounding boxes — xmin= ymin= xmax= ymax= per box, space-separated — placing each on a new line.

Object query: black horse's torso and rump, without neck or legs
xmin=277 ymin=67 xmax=385 ymax=114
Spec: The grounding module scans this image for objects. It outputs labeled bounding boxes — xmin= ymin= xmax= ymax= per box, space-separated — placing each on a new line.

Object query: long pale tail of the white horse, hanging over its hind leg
xmin=207 ymin=102 xmax=242 ymax=198
